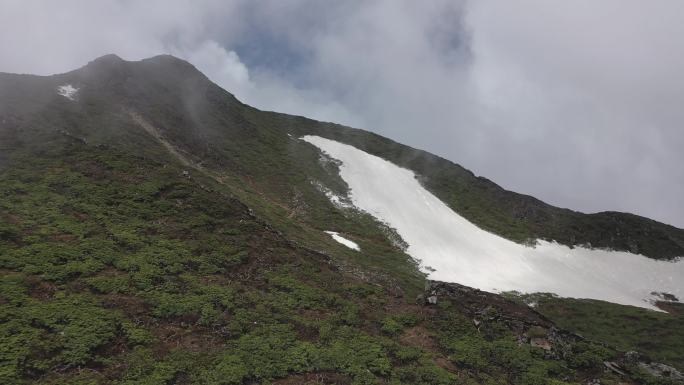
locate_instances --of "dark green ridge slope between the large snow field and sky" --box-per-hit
[288,123,684,259]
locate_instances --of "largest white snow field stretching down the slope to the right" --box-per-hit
[302,136,684,310]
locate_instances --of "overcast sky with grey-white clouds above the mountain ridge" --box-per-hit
[0,0,684,227]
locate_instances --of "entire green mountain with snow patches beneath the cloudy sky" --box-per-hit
[0,55,684,384]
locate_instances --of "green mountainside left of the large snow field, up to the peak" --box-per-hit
[0,54,680,384]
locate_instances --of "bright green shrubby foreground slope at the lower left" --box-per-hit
[0,138,656,384]
